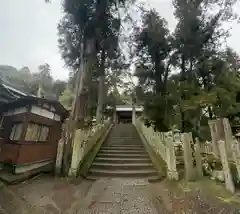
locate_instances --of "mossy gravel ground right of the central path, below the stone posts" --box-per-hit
[151,180,240,214]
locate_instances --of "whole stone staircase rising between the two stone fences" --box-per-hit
[87,124,159,181]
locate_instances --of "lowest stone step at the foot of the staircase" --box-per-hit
[89,168,158,178]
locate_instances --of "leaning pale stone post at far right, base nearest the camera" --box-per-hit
[218,140,235,193]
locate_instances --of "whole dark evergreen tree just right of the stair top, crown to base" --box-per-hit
[131,10,172,131]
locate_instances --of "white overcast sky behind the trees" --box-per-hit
[0,0,240,79]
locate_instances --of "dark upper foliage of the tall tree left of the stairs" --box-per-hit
[58,0,131,69]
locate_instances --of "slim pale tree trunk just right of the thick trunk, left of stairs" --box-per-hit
[96,50,106,124]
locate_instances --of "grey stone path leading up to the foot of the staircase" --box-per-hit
[69,179,158,214]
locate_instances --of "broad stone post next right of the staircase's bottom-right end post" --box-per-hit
[182,133,195,181]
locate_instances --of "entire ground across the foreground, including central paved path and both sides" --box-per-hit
[0,175,240,214]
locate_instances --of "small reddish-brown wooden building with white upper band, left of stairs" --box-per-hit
[0,96,68,174]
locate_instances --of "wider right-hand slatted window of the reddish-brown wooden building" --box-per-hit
[25,123,49,142]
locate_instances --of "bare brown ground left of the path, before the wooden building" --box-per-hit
[0,175,92,214]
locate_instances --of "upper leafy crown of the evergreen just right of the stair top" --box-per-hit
[134,10,171,94]
